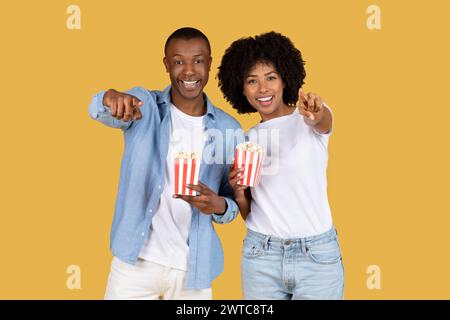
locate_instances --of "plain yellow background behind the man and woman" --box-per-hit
[0,0,450,299]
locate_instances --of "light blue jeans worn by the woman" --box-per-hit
[242,228,344,300]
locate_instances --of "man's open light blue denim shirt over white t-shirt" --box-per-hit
[89,86,244,289]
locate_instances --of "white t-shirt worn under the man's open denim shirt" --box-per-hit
[139,105,206,271]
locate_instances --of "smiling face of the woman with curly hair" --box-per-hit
[243,62,292,121]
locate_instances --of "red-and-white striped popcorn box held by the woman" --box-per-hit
[234,142,264,187]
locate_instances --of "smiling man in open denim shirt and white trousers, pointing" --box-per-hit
[89,28,242,299]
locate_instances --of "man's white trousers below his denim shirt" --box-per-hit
[105,257,212,300]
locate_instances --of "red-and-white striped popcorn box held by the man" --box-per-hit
[175,152,201,196]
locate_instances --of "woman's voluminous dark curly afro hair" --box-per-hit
[217,31,306,113]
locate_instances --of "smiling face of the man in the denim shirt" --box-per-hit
[163,38,212,100]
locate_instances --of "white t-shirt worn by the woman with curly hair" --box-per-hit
[246,108,333,238]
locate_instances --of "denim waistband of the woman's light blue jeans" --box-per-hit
[247,227,337,247]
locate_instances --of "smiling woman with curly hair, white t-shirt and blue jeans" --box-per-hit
[218,32,344,299]
